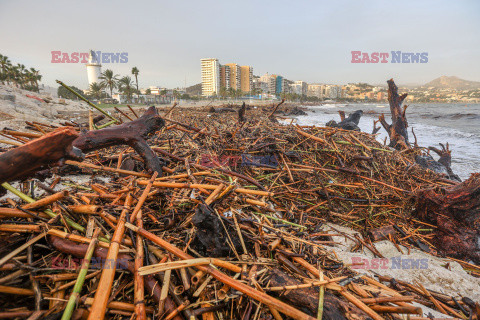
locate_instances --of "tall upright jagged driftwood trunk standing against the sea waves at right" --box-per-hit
[378,79,409,150]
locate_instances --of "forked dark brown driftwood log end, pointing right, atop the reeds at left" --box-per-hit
[73,106,165,176]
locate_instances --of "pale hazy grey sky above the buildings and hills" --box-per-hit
[0,0,480,89]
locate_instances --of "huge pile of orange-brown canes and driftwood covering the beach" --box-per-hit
[0,80,480,320]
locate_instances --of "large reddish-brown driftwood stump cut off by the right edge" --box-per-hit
[416,173,480,263]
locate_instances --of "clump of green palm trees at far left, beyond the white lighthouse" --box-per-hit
[0,54,42,92]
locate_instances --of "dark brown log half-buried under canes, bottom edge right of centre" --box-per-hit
[269,269,369,320]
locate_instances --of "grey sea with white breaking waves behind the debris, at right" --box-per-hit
[290,103,480,180]
